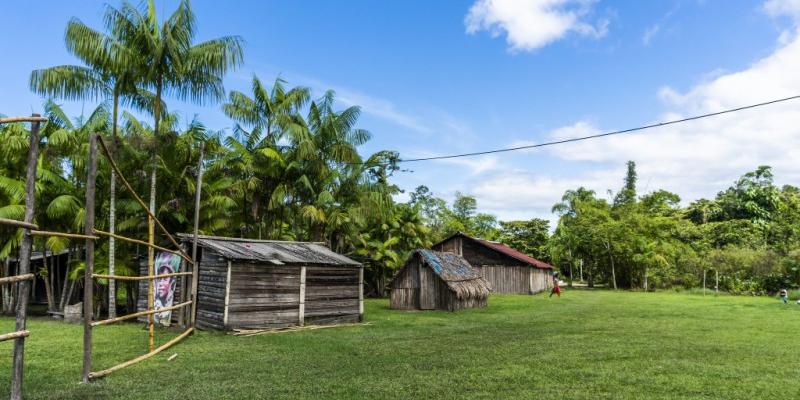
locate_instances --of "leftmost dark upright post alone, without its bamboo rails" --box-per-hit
[11,114,40,400]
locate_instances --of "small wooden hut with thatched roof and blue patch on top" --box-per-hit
[390,250,489,311]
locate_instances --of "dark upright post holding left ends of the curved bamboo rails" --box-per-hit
[83,134,97,383]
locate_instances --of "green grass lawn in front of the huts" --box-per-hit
[0,291,800,400]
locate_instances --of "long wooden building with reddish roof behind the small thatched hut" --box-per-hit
[432,232,553,294]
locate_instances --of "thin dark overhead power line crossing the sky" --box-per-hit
[398,95,800,163]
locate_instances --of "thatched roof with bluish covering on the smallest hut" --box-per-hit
[411,249,490,299]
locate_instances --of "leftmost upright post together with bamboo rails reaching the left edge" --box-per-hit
[0,114,41,400]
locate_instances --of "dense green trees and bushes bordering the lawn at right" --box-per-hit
[550,163,800,294]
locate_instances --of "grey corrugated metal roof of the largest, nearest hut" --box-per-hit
[178,234,361,266]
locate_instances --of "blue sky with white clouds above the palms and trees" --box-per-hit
[0,0,800,227]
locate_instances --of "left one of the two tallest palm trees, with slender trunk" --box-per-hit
[30,14,154,318]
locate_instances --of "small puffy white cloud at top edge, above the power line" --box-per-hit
[464,0,608,51]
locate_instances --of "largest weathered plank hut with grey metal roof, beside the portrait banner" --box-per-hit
[139,235,364,330]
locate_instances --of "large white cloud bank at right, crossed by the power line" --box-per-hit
[550,30,800,200]
